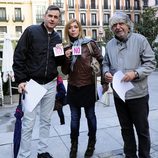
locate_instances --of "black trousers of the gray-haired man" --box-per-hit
[114,95,150,158]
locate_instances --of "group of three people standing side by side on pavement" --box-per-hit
[13,5,156,158]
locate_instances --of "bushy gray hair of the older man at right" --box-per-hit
[109,12,132,30]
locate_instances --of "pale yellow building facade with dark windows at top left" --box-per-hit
[0,0,32,39]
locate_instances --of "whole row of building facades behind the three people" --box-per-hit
[0,0,148,40]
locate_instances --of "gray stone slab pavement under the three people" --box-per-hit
[0,71,158,158]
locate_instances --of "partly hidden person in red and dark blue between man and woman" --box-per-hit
[54,75,67,125]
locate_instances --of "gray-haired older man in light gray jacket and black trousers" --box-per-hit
[102,12,156,158]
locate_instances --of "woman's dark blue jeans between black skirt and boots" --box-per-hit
[70,105,97,139]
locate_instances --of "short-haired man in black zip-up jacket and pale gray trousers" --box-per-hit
[13,5,64,158]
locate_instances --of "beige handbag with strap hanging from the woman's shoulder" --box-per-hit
[87,43,101,76]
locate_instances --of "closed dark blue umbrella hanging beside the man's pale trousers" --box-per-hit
[13,94,24,158]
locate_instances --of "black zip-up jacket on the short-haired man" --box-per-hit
[13,23,64,84]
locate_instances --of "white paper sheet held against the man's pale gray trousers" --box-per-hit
[22,79,47,112]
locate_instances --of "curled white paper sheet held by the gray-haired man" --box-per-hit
[112,71,134,102]
